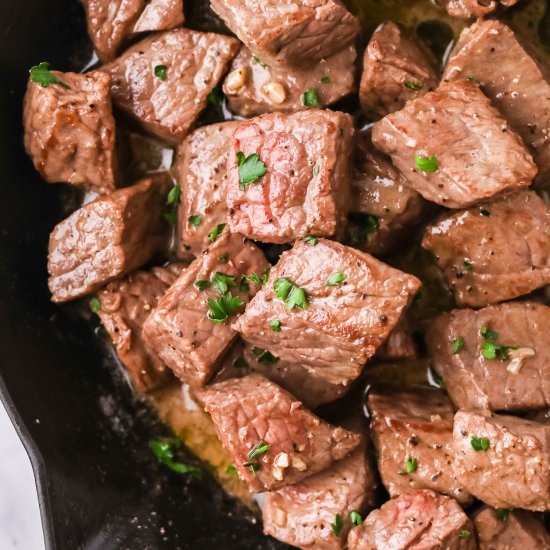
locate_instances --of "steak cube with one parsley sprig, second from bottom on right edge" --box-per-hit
[453,410,550,511]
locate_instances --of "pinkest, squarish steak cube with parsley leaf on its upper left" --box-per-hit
[227,109,353,243]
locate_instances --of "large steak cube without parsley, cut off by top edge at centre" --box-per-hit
[210,0,359,66]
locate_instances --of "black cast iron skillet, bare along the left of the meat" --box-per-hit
[0,0,284,550]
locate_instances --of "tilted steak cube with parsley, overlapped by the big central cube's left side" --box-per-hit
[143,226,268,387]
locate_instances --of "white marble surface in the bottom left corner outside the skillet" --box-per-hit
[0,402,44,550]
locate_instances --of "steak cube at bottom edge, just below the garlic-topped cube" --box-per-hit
[263,446,376,550]
